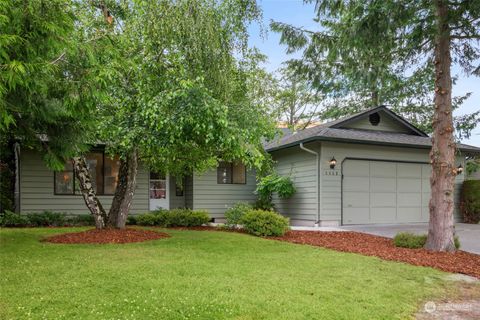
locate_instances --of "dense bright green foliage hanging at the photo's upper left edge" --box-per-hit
[0,0,105,168]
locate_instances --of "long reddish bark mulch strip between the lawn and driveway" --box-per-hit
[270,230,480,279]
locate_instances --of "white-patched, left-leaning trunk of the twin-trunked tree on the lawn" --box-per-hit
[73,157,107,229]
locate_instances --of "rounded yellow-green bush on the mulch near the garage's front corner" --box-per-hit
[241,210,289,236]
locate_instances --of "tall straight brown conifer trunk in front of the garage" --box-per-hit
[425,0,456,251]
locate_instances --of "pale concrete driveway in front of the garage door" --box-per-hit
[340,223,480,254]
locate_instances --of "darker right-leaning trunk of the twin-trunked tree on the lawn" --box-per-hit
[108,150,138,229]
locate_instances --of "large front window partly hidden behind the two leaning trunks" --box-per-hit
[54,151,120,195]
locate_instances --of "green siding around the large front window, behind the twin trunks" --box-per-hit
[20,150,148,214]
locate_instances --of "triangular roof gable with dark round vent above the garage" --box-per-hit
[329,106,428,137]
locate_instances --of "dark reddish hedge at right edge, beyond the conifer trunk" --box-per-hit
[460,180,480,223]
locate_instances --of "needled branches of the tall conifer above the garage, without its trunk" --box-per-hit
[271,0,480,139]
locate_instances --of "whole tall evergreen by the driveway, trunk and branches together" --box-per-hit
[272,0,480,251]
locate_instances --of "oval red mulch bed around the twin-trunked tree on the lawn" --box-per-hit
[44,228,170,244]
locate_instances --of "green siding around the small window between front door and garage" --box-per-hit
[193,169,256,218]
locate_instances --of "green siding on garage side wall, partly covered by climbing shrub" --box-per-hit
[272,143,320,224]
